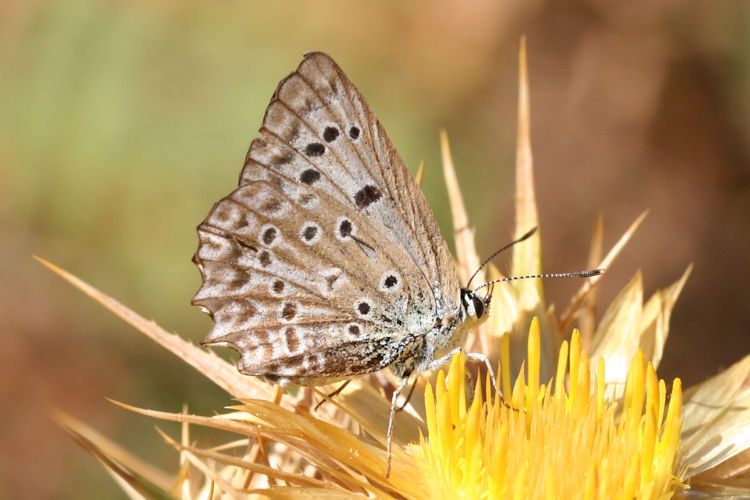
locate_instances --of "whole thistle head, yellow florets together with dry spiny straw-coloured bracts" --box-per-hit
[40,40,750,499]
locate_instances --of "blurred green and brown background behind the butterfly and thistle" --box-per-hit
[0,0,750,498]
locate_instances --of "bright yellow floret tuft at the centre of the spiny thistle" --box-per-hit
[412,320,682,499]
